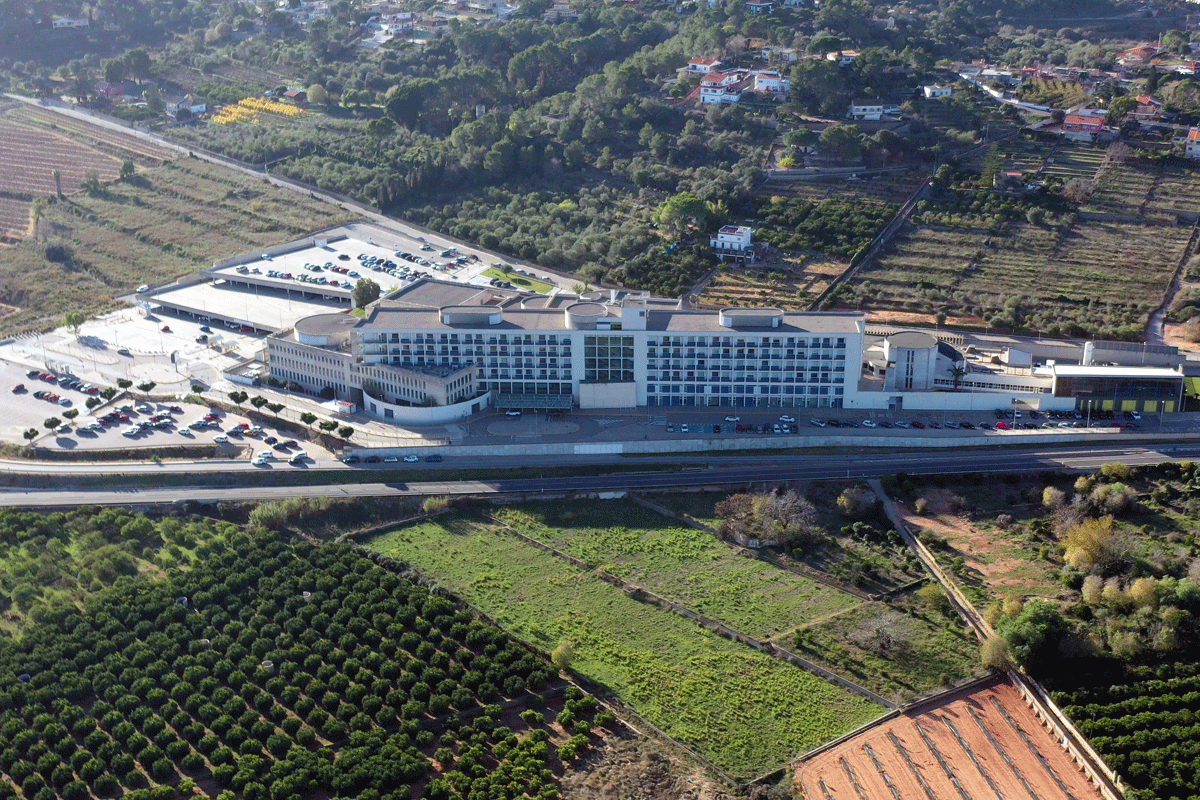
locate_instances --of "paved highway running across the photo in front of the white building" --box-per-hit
[0,443,1200,507]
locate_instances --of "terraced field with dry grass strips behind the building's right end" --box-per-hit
[841,211,1192,339]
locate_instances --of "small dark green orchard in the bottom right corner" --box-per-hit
[1054,662,1200,798]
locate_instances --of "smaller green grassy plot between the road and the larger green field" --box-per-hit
[496,500,858,638]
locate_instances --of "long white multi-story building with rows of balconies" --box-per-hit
[266,281,864,423]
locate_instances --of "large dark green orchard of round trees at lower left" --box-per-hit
[0,511,614,800]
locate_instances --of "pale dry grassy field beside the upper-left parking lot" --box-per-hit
[0,148,352,335]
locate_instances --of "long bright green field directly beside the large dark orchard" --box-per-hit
[367,515,881,776]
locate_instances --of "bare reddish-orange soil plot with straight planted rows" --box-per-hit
[796,678,1100,800]
